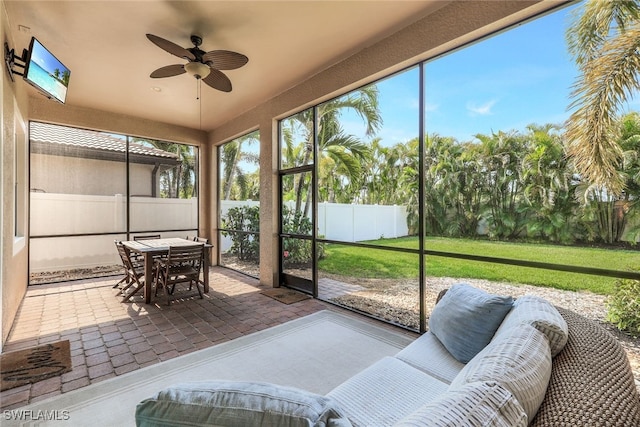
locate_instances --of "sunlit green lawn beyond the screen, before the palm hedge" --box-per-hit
[319,237,640,295]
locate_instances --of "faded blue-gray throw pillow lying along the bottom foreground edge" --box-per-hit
[136,381,351,427]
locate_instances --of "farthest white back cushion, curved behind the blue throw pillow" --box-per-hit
[496,295,569,357]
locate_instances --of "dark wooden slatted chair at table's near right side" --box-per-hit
[155,245,204,305]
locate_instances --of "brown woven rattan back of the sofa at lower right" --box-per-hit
[530,307,640,427]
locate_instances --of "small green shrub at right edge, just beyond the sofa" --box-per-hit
[607,279,640,337]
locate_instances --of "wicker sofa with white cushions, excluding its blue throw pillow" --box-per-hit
[136,285,640,427]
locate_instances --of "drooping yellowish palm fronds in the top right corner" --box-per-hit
[567,0,640,194]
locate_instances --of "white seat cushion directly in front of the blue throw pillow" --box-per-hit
[395,332,464,384]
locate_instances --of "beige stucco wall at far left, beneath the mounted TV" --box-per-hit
[0,2,28,351]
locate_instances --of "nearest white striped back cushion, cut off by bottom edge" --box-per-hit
[395,381,527,427]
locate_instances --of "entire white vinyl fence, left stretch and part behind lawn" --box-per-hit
[30,192,408,272]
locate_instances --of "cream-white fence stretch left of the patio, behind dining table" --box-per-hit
[29,192,198,272]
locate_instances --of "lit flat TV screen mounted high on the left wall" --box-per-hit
[24,37,71,104]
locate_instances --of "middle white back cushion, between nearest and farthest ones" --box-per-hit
[449,324,551,420]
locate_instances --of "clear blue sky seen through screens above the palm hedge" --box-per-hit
[343,1,577,145]
